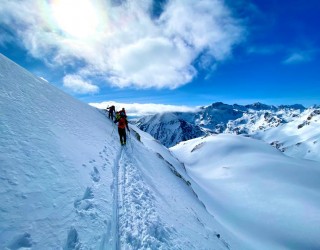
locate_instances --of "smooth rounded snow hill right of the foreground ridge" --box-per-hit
[171,134,320,249]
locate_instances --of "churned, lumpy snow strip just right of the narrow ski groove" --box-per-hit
[118,145,175,249]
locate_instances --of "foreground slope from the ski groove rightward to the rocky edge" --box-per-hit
[109,128,244,250]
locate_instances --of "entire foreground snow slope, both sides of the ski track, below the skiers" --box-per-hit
[0,55,248,249]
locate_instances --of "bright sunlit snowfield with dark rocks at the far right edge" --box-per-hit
[254,107,320,162]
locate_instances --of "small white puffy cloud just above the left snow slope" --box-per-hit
[63,75,99,94]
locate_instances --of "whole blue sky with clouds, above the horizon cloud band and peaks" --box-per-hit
[0,0,320,106]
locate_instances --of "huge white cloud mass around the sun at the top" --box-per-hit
[0,0,243,88]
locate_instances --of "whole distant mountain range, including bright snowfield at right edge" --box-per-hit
[136,102,320,160]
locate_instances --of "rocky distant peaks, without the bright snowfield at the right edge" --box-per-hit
[136,102,305,147]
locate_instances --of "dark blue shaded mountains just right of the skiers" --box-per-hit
[136,102,243,147]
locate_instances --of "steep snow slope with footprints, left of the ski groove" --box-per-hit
[0,52,119,249]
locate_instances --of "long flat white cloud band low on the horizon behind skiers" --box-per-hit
[90,101,198,117]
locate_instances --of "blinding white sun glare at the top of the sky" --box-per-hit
[51,0,99,38]
